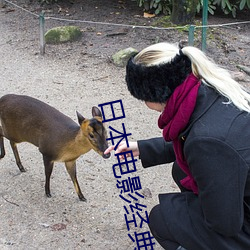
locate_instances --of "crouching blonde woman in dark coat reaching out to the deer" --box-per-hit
[105,43,250,250]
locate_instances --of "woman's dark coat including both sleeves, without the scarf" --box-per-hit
[138,85,250,250]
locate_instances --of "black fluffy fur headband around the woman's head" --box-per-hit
[126,51,192,103]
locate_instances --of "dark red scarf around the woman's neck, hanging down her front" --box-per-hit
[158,73,200,194]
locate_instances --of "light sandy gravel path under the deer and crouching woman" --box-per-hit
[0,3,176,250]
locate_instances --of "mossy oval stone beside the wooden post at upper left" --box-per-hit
[45,26,82,44]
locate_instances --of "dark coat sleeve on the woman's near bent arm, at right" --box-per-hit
[184,137,248,237]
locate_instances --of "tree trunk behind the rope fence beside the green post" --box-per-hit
[171,0,198,25]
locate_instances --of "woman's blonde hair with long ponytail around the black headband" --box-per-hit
[134,43,250,113]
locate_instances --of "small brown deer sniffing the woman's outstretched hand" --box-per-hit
[0,94,110,201]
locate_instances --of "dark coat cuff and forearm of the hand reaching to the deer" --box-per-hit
[138,137,175,168]
